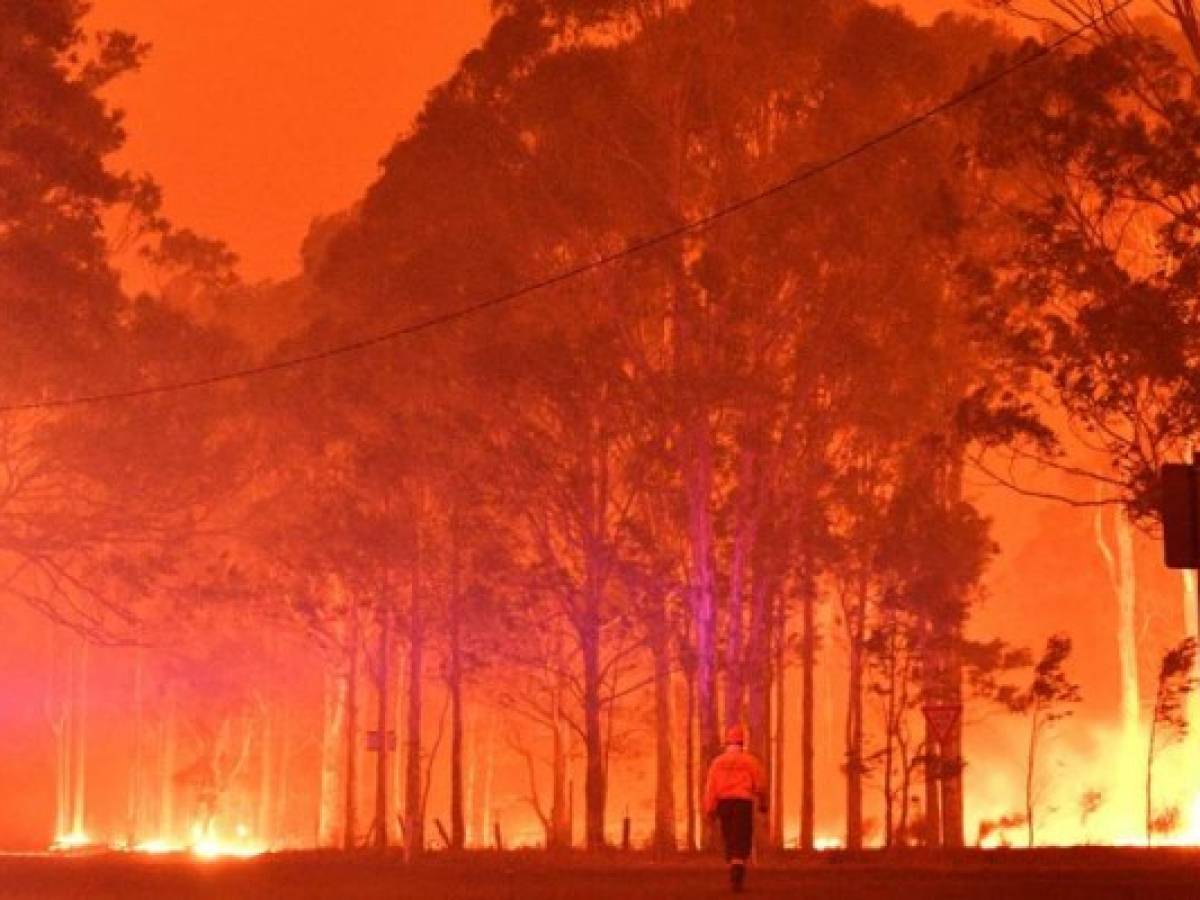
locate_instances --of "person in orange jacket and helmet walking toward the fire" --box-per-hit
[704,725,767,893]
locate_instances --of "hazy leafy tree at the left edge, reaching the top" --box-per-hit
[0,0,255,643]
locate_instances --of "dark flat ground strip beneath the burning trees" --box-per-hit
[0,848,1200,900]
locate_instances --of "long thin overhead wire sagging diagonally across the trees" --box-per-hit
[0,0,1133,413]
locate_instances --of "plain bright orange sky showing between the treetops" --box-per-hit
[91,0,984,280]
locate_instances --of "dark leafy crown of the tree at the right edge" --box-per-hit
[973,32,1200,522]
